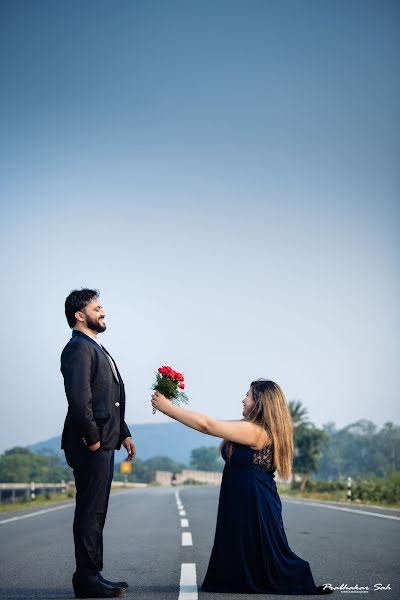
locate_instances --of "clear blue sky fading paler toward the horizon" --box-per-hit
[0,0,400,451]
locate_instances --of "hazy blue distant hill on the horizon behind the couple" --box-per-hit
[28,422,221,465]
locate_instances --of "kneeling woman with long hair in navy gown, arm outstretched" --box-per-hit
[152,379,332,595]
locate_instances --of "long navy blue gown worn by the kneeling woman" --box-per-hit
[201,444,332,595]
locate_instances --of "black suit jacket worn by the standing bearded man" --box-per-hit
[61,330,131,450]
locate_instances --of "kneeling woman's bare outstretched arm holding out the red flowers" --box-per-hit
[151,392,268,450]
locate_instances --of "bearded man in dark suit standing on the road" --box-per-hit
[61,289,136,598]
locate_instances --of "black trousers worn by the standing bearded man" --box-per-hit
[64,445,114,576]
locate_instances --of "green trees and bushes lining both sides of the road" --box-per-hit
[0,400,400,510]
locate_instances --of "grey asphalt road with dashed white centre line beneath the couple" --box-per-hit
[0,486,400,600]
